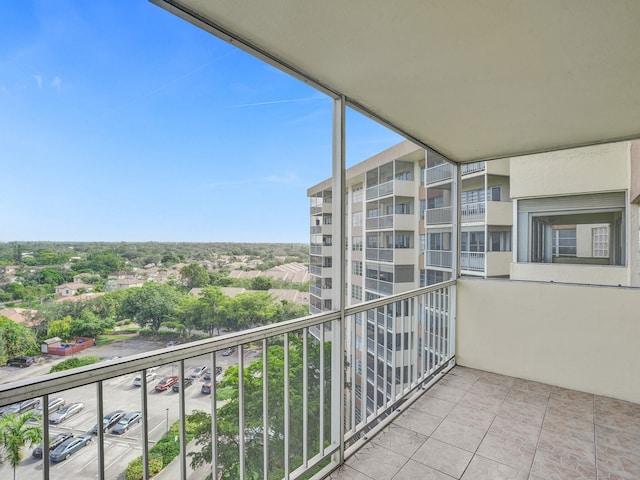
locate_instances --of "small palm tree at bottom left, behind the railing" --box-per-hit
[0,413,42,480]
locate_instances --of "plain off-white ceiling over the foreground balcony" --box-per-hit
[152,0,640,162]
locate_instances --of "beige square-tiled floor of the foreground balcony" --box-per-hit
[329,367,640,480]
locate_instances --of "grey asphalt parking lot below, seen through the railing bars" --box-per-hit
[0,341,258,480]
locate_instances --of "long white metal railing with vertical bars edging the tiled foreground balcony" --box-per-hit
[0,281,456,480]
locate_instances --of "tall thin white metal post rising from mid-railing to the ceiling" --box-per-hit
[331,96,346,463]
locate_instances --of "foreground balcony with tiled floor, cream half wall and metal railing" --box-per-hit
[5,279,640,480]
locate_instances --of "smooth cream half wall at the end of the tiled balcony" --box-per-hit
[456,279,640,403]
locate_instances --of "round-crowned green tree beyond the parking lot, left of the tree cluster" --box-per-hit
[119,282,180,334]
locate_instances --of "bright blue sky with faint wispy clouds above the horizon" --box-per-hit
[0,0,401,243]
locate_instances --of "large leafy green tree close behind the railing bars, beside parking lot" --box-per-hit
[190,335,331,480]
